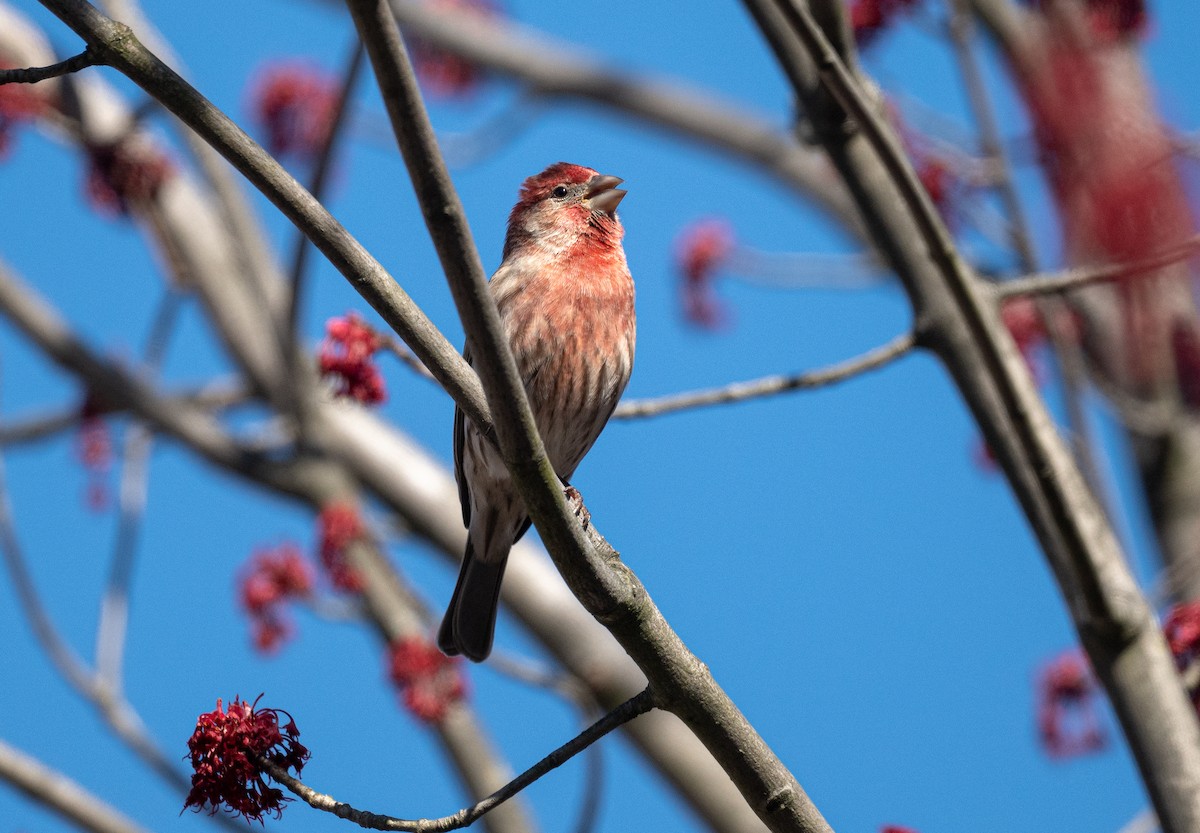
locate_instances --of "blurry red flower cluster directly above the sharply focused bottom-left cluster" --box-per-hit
[241,544,313,653]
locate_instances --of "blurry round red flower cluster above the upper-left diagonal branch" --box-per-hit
[251,62,340,158]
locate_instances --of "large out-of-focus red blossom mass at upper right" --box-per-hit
[1021,19,1195,389]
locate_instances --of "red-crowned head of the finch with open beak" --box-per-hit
[504,162,625,258]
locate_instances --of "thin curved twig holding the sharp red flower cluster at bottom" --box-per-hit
[262,688,655,833]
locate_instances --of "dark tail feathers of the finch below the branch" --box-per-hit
[438,535,508,663]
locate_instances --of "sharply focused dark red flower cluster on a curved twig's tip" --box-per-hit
[184,697,308,822]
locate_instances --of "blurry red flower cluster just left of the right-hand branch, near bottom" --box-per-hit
[1038,651,1108,757]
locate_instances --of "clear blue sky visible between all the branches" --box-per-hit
[0,0,1200,833]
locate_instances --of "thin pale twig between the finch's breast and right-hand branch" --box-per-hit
[613,332,917,419]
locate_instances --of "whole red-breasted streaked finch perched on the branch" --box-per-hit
[438,162,636,663]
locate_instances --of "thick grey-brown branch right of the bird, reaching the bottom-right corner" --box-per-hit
[763,0,1200,833]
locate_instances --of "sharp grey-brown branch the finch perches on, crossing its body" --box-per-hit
[348,0,828,831]
